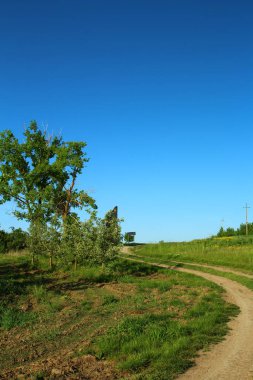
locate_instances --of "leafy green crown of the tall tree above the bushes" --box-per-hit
[0,121,96,223]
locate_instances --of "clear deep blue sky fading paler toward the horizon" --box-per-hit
[0,0,253,241]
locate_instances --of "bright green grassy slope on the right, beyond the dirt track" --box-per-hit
[131,237,253,272]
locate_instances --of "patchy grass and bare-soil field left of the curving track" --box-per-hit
[0,256,238,380]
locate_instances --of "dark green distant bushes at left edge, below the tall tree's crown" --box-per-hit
[0,227,28,253]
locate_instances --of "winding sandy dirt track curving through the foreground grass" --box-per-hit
[125,258,253,380]
